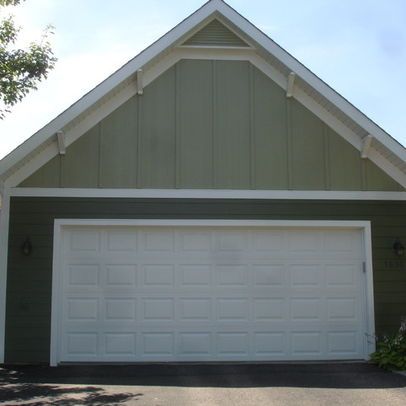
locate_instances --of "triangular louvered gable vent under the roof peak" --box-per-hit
[182,20,250,48]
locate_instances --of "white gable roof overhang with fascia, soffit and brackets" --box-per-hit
[0,0,406,187]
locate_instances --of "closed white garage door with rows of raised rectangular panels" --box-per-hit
[53,226,366,362]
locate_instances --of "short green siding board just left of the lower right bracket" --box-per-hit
[327,127,362,190]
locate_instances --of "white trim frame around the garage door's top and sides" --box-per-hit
[50,219,375,366]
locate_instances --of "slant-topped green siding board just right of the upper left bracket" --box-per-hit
[139,67,176,188]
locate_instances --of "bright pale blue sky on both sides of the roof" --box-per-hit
[0,0,406,158]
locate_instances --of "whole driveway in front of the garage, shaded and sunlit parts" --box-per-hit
[0,363,406,406]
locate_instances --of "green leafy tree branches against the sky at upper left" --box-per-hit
[0,0,56,120]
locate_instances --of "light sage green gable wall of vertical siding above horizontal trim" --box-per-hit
[21,60,403,191]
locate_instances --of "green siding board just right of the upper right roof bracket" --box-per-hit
[291,100,325,190]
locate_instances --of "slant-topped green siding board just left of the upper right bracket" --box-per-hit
[253,69,289,189]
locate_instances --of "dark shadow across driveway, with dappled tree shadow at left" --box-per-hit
[0,363,406,406]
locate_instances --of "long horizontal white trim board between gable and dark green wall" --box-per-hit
[8,188,406,201]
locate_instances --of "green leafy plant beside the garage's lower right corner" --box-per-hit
[371,319,406,370]
